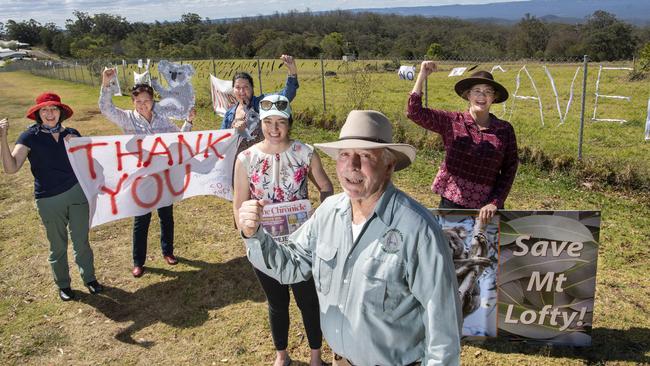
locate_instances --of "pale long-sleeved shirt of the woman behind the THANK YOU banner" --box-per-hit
[99,87,192,135]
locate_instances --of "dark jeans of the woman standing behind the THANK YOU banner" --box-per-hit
[133,205,174,266]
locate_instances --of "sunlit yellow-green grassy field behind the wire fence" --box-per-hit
[24,60,650,188]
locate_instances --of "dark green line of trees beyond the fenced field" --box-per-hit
[0,11,650,61]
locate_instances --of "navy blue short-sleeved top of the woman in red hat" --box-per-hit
[16,124,81,198]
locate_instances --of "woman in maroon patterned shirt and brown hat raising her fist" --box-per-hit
[407,61,519,223]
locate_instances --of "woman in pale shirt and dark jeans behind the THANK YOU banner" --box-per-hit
[99,69,196,277]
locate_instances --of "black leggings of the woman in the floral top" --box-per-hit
[254,268,323,351]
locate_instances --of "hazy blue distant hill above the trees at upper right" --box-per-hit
[351,0,650,25]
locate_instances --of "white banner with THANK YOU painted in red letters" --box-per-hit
[65,129,238,227]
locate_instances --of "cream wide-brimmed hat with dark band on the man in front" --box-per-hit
[314,110,415,171]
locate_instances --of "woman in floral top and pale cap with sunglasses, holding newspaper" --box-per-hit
[233,94,333,366]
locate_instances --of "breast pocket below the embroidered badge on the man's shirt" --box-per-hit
[362,256,406,313]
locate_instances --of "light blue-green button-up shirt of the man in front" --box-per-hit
[245,184,462,366]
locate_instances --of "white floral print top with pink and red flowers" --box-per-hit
[237,140,314,203]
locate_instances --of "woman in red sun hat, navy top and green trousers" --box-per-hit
[0,93,103,301]
